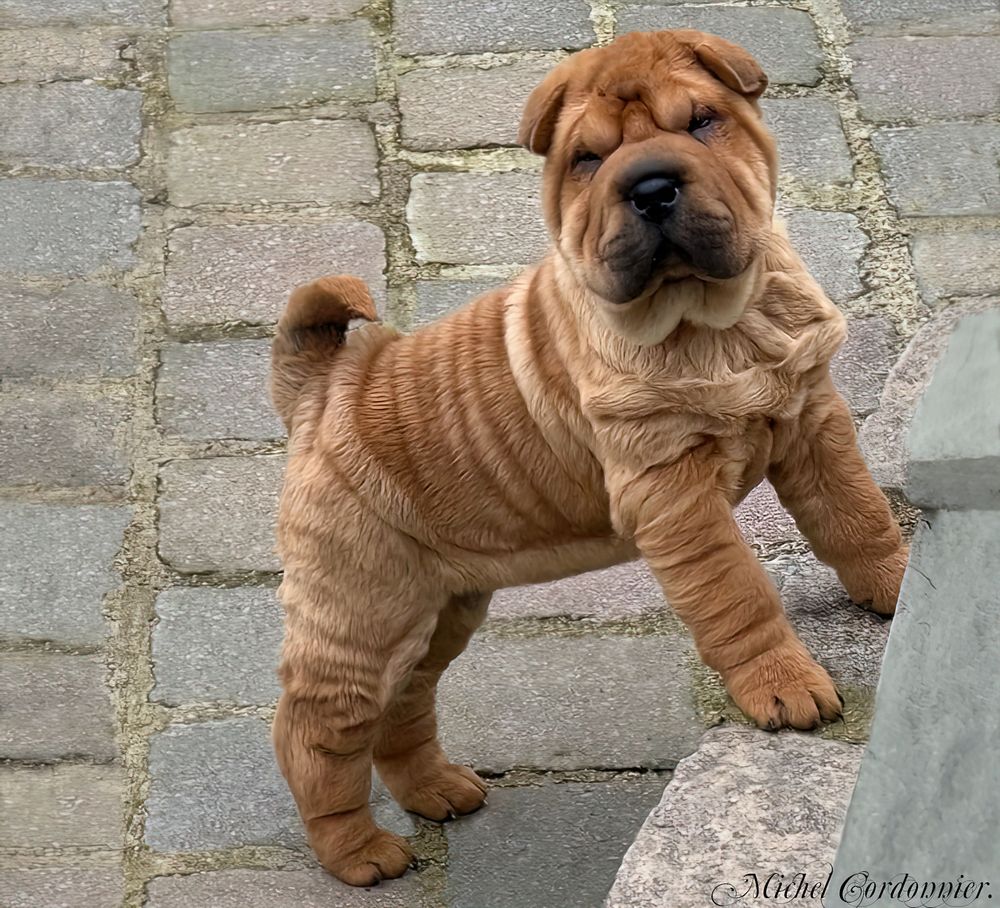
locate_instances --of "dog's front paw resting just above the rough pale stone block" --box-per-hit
[724,640,844,731]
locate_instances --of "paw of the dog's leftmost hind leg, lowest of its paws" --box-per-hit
[306,808,413,886]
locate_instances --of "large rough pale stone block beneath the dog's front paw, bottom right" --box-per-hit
[605,726,862,908]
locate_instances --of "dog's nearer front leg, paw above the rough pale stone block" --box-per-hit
[606,452,842,729]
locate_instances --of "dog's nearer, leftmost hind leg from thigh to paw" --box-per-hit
[273,569,436,886]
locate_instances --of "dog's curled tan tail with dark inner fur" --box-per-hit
[271,275,378,430]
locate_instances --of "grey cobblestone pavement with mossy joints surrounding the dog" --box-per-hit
[0,0,1000,908]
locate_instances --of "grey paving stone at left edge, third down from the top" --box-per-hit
[0,82,142,169]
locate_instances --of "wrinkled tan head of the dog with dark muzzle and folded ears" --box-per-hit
[519,30,777,336]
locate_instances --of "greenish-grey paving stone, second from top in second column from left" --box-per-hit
[167,19,375,113]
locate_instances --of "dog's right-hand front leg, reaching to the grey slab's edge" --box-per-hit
[768,378,909,615]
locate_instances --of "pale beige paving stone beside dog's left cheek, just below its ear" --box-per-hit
[406,173,549,265]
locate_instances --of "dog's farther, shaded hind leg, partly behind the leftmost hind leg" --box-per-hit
[375,593,490,820]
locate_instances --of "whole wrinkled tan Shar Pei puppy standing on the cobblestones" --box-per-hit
[272,31,907,885]
